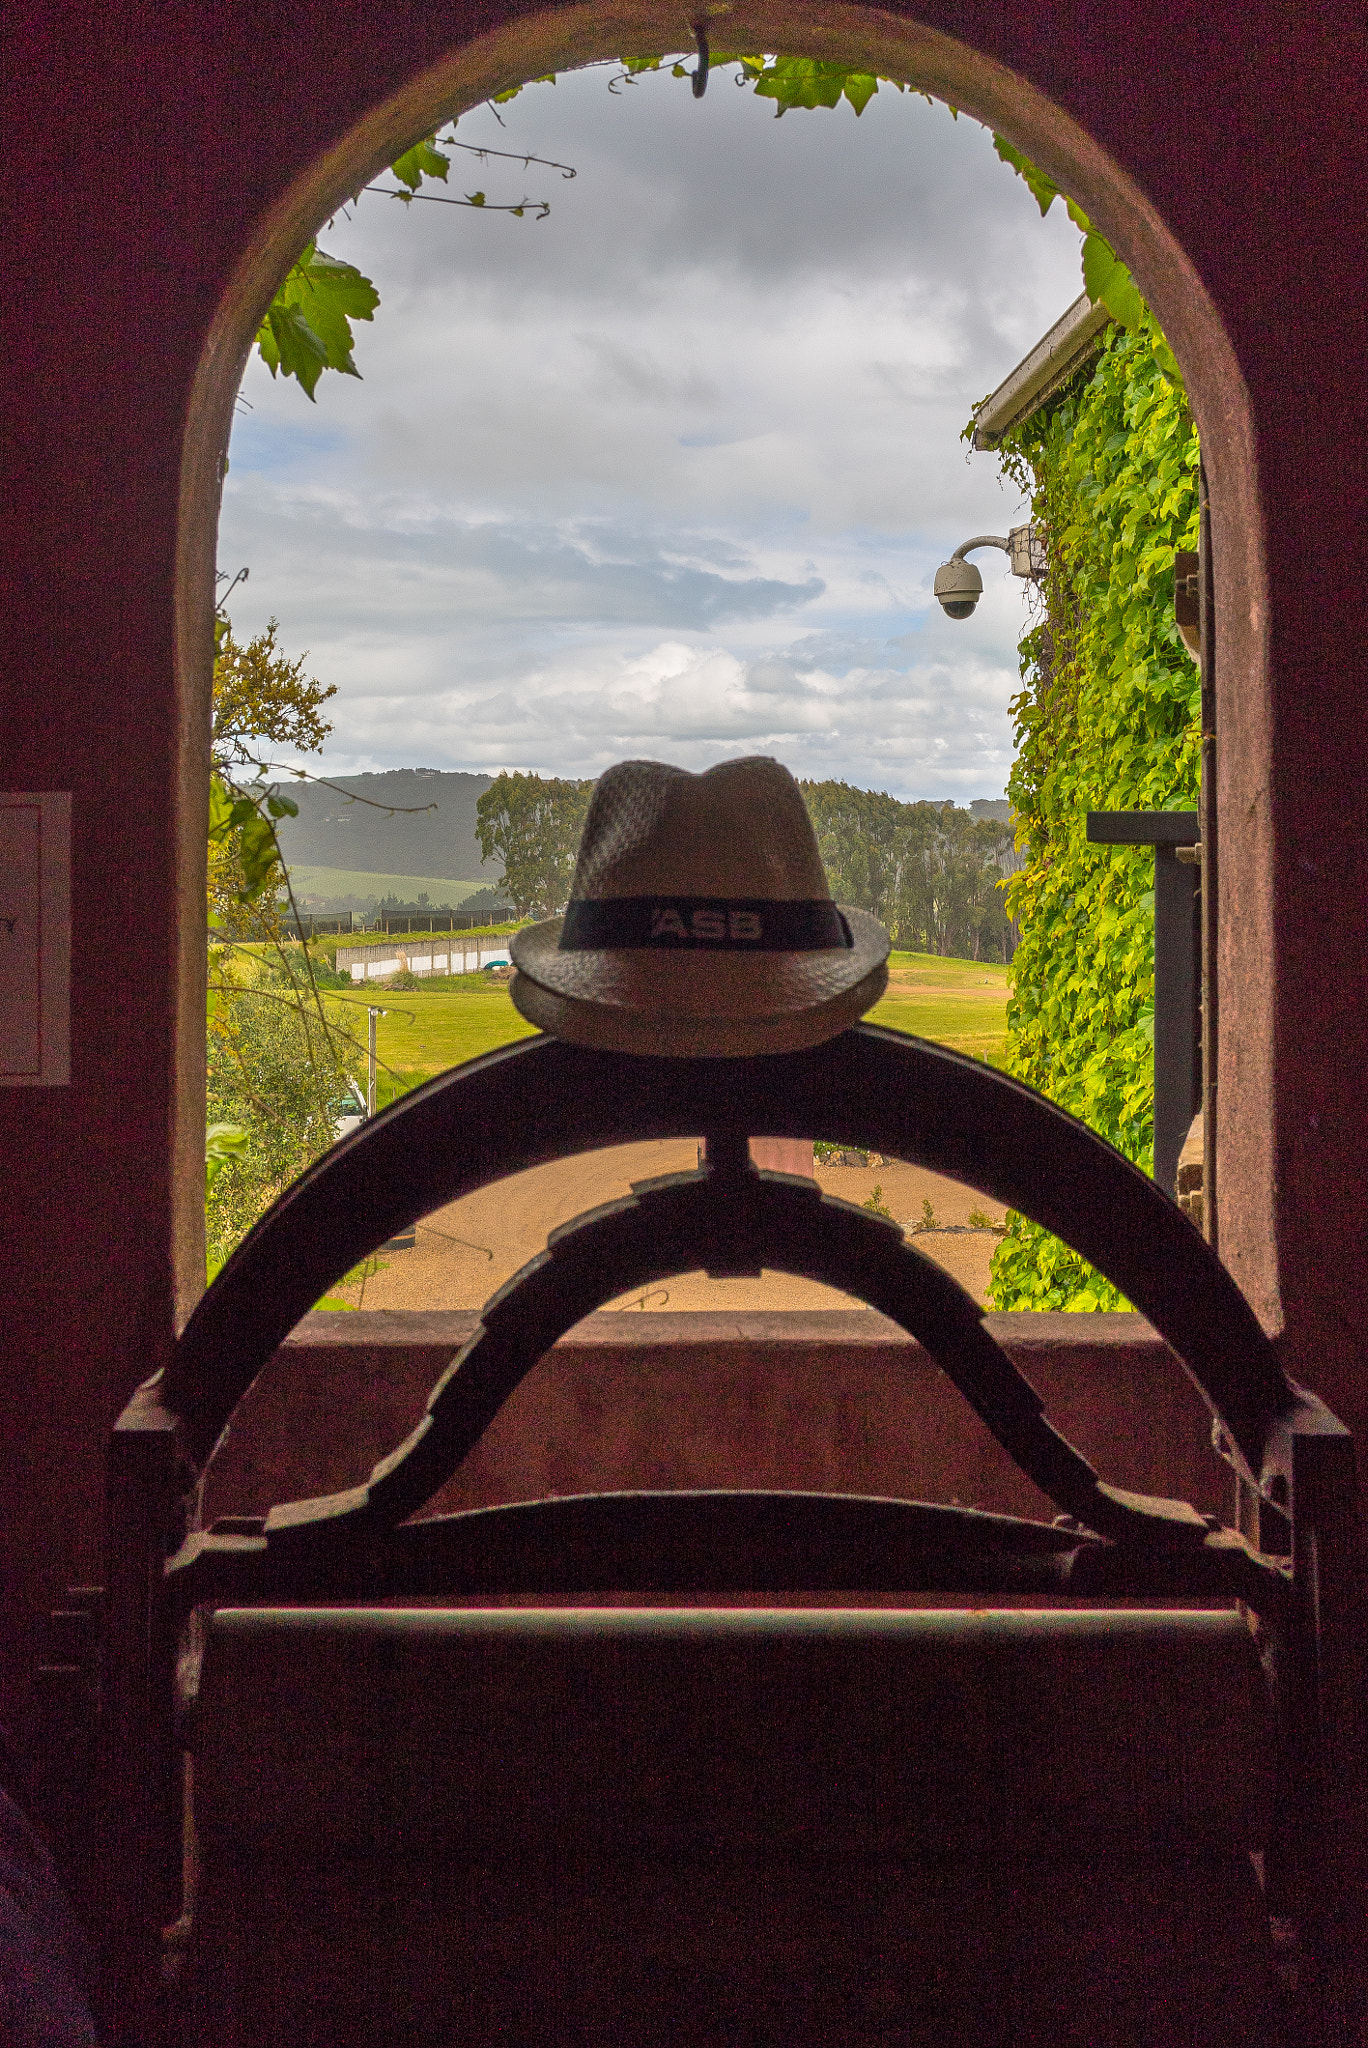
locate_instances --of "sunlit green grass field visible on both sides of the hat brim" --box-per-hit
[348,952,1008,1102]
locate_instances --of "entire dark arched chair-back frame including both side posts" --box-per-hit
[104,1040,1362,2048]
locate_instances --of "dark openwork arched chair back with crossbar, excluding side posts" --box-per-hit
[125,1024,1359,1622]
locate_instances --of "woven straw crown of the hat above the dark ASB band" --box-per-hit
[571,754,831,903]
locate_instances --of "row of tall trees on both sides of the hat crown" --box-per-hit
[475,774,1018,961]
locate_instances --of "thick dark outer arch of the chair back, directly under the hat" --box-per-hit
[167,1024,1311,1487]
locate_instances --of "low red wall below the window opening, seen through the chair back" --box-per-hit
[203,1309,1235,1524]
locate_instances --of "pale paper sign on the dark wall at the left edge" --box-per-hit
[0,791,72,1087]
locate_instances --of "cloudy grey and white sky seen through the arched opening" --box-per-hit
[219,68,1081,803]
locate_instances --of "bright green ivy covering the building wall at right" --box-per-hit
[993,313,1200,1309]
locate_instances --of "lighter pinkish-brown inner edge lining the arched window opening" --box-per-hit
[176,0,1280,1325]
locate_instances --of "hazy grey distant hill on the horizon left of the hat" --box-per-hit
[276,768,504,883]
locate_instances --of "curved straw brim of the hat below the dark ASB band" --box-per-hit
[510,905,889,1059]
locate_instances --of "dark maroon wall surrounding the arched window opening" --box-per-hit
[0,0,1368,1728]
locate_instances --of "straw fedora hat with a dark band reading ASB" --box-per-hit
[510,756,889,1057]
